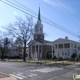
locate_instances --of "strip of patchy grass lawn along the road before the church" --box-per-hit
[2,59,71,67]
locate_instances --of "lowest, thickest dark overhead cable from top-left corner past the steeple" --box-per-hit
[1,1,78,37]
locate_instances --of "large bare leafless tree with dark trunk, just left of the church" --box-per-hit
[6,17,33,61]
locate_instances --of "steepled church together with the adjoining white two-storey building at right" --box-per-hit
[28,8,80,59]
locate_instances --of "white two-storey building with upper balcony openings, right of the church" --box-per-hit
[53,37,80,59]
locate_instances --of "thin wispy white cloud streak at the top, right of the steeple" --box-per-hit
[42,0,74,14]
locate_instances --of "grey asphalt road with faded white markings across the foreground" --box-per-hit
[0,62,80,80]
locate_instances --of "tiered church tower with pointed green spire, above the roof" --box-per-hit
[34,7,44,40]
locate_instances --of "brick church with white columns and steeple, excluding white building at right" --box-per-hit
[28,8,54,59]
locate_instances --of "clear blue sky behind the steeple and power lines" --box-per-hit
[0,0,80,41]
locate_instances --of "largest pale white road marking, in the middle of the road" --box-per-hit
[30,67,63,73]
